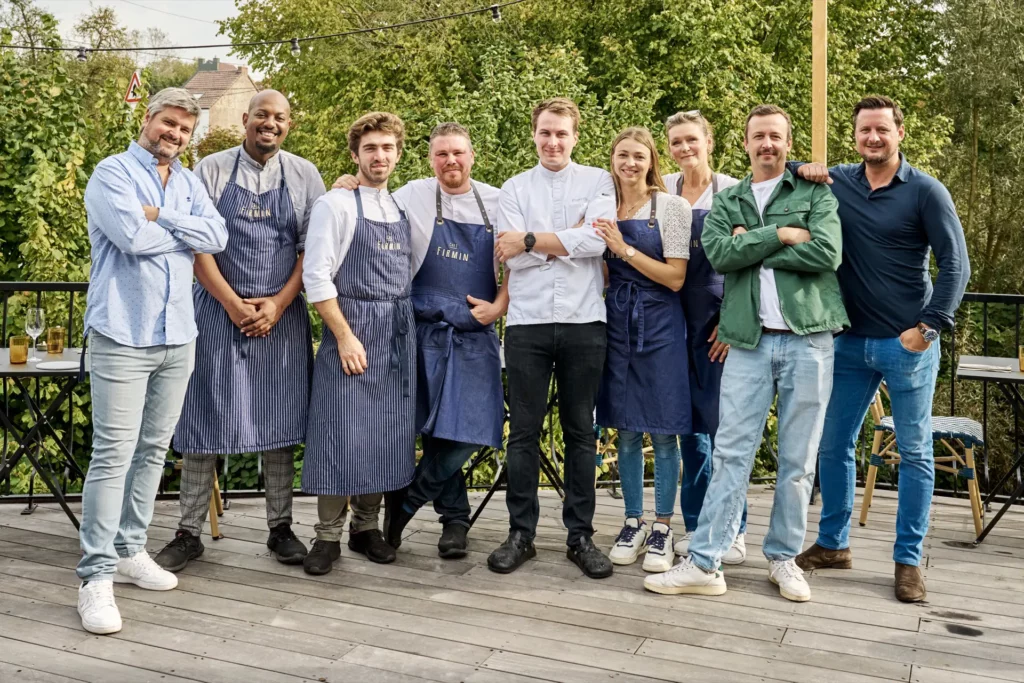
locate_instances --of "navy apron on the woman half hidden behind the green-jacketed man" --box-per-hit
[676,173,725,436]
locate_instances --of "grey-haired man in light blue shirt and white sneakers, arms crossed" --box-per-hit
[77,88,227,634]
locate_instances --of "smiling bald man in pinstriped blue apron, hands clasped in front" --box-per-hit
[157,90,325,571]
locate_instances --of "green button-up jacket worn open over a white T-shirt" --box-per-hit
[700,171,850,349]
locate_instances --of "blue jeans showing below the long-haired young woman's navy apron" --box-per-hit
[618,429,679,517]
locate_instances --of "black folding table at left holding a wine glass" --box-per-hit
[0,348,85,528]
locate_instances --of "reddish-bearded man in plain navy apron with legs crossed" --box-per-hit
[335,123,508,558]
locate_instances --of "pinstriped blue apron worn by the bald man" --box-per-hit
[174,150,312,454]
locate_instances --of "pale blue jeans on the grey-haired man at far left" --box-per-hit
[77,333,196,581]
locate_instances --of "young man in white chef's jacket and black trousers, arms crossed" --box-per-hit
[487,97,615,579]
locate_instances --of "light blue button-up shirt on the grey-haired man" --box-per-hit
[85,142,227,347]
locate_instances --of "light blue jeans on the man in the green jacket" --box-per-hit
[690,332,833,571]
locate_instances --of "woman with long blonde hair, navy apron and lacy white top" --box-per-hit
[594,128,690,571]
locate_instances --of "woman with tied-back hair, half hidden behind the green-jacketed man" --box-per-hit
[665,110,746,564]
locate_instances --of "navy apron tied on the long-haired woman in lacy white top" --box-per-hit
[597,195,691,434]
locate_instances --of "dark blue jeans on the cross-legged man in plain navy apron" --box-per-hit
[402,435,480,528]
